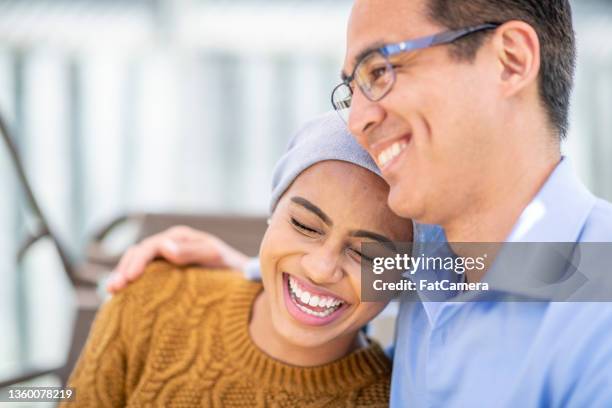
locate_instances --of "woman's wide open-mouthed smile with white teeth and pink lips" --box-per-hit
[283,272,350,326]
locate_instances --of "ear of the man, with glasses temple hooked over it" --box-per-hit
[493,21,541,96]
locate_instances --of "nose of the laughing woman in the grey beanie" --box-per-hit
[302,244,343,284]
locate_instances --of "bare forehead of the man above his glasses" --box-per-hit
[344,0,432,68]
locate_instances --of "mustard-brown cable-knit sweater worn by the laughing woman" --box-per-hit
[65,261,391,407]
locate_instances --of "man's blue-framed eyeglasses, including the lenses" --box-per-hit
[331,23,501,123]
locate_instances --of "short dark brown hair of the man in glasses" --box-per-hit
[427,0,576,139]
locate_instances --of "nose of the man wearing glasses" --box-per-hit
[348,87,385,150]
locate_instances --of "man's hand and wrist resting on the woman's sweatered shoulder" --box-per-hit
[107,226,260,293]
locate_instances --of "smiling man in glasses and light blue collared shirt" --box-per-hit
[332,0,612,407]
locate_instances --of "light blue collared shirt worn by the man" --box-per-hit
[391,159,612,407]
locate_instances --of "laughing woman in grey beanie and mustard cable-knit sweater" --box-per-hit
[61,113,412,407]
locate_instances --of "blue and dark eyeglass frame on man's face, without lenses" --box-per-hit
[331,22,503,113]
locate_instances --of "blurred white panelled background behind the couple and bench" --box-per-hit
[0,0,612,396]
